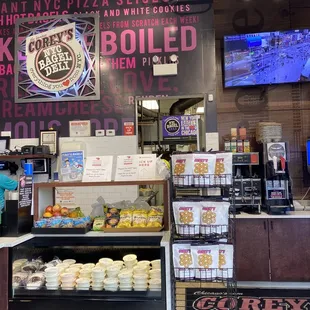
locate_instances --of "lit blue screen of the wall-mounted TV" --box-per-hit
[224,29,310,87]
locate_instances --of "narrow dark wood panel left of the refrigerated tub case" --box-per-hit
[0,248,9,310]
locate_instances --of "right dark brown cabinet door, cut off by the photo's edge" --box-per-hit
[269,219,310,282]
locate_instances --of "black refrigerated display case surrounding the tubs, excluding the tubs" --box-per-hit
[9,232,170,310]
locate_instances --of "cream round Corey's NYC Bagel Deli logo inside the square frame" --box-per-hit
[26,23,85,92]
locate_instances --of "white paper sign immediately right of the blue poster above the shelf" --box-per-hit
[83,156,113,182]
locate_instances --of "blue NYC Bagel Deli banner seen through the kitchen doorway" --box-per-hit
[162,115,198,139]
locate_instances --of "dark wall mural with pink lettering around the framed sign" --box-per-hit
[0,0,215,138]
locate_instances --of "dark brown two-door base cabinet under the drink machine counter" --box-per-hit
[236,211,310,282]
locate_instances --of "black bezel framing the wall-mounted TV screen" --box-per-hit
[221,27,310,89]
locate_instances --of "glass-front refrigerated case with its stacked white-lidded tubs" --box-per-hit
[9,233,166,310]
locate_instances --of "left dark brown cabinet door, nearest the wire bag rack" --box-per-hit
[236,219,269,281]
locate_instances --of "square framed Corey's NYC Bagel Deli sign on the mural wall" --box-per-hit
[15,14,100,103]
